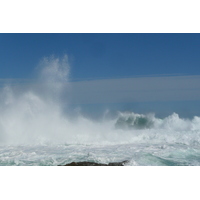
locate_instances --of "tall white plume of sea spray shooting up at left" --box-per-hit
[0,55,69,144]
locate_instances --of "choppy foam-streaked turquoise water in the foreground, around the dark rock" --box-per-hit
[0,141,200,166]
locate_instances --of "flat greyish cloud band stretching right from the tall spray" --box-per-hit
[69,76,200,104]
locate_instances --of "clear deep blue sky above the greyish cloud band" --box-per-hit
[0,34,200,79]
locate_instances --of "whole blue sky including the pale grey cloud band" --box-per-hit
[0,34,200,116]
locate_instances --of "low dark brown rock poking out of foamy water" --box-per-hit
[59,160,128,166]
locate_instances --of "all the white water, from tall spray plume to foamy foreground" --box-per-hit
[0,56,200,165]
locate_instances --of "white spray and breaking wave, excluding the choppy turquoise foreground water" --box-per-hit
[0,55,200,145]
